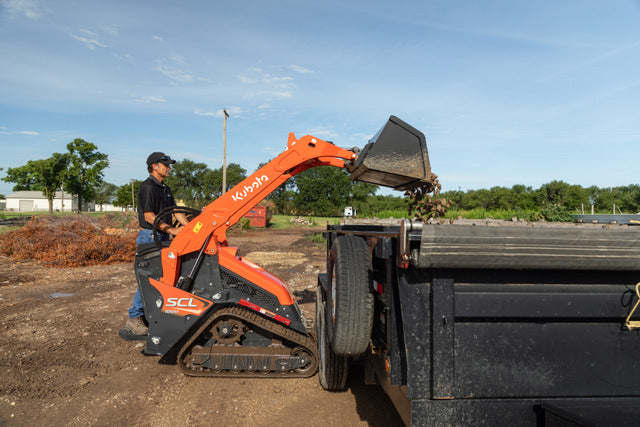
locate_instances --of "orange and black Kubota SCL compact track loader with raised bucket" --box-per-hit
[122,116,430,378]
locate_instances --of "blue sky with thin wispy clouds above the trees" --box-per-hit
[0,0,640,195]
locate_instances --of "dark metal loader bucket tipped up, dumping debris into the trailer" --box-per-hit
[349,116,431,190]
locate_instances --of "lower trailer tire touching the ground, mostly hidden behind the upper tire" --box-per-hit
[315,286,349,391]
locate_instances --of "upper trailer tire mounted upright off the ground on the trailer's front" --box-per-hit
[326,234,373,356]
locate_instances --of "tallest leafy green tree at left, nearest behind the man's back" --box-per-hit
[65,138,109,212]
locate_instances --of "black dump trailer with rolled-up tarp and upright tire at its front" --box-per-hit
[316,220,640,426]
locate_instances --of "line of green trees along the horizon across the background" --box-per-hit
[2,138,640,217]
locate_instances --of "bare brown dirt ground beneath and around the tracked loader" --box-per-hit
[0,228,402,426]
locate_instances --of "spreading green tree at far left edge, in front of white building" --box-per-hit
[3,153,69,214]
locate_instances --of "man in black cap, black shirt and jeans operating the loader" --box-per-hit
[125,152,188,336]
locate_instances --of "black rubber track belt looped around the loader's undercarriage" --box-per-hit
[178,307,318,378]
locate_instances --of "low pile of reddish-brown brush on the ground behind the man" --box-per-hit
[0,215,137,267]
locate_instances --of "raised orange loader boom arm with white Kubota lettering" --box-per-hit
[161,133,356,286]
